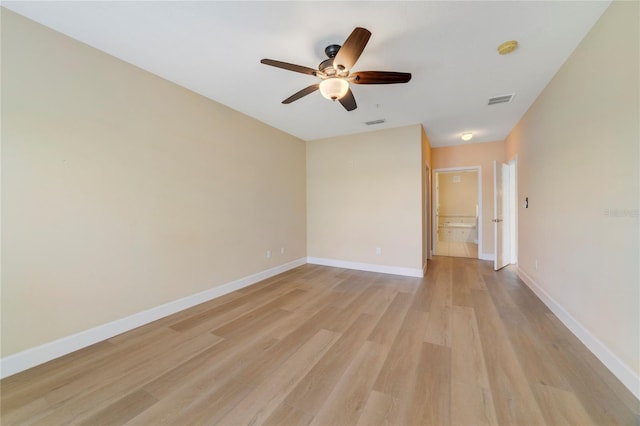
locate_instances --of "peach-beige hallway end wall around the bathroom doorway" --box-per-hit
[431,141,505,258]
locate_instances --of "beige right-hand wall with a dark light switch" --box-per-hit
[506,2,640,386]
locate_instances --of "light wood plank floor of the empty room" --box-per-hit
[0,257,639,425]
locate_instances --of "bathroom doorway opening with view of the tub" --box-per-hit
[433,167,482,259]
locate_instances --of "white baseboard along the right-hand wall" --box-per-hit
[518,267,640,399]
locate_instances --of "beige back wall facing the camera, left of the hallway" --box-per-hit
[307,125,422,269]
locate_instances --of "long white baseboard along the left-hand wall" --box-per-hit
[0,258,306,378]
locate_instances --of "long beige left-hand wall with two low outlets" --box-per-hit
[2,9,306,356]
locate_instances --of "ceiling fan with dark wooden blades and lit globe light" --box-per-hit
[260,27,411,111]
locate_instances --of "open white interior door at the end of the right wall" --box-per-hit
[493,161,510,271]
